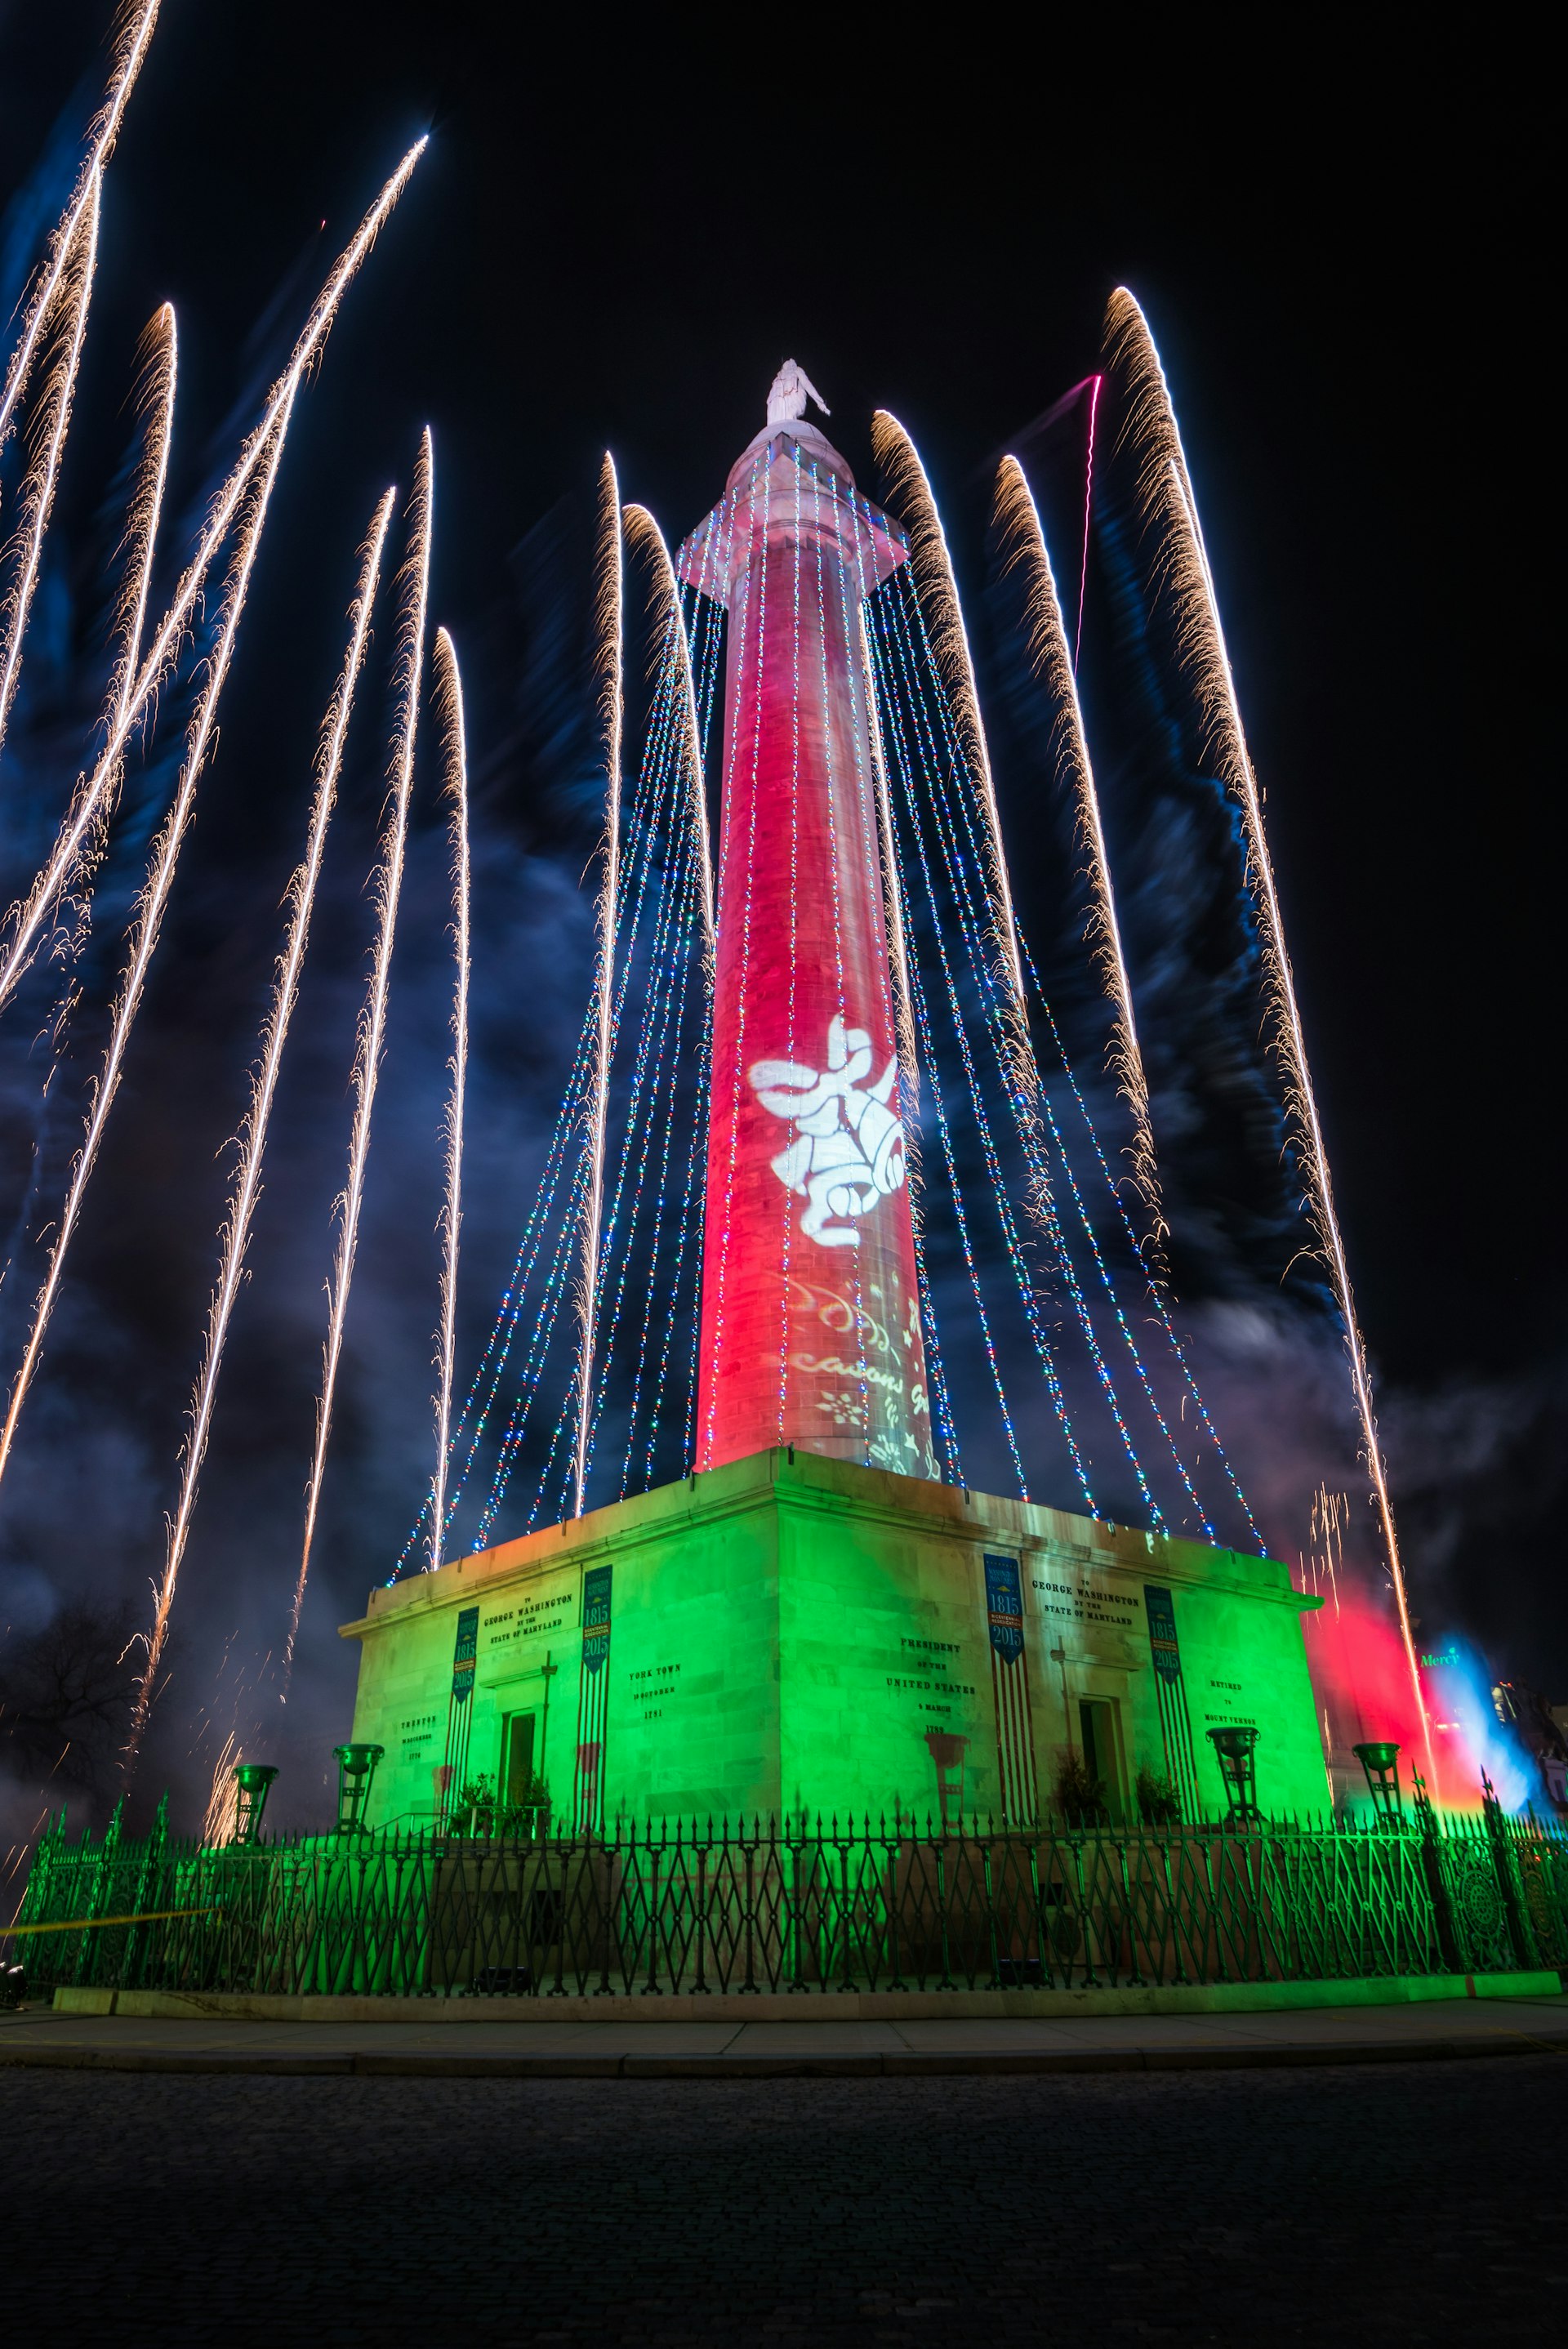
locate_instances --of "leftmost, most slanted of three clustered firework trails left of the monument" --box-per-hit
[145,491,394,1719]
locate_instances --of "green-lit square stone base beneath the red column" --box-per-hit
[343,1449,1329,1830]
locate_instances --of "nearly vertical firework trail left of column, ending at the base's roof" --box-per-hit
[572,456,625,1518]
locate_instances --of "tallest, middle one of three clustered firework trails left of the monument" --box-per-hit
[282,427,434,1672]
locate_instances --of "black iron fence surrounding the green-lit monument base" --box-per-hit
[7,1804,1568,1997]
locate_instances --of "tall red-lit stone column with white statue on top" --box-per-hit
[679,362,937,1475]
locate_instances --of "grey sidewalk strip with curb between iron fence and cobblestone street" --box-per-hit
[0,2032,1568,2079]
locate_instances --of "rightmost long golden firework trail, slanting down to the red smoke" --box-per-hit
[1106,287,1434,1772]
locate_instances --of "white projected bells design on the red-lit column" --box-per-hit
[746,1019,906,1247]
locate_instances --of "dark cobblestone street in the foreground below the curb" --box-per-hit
[0,2056,1568,2349]
